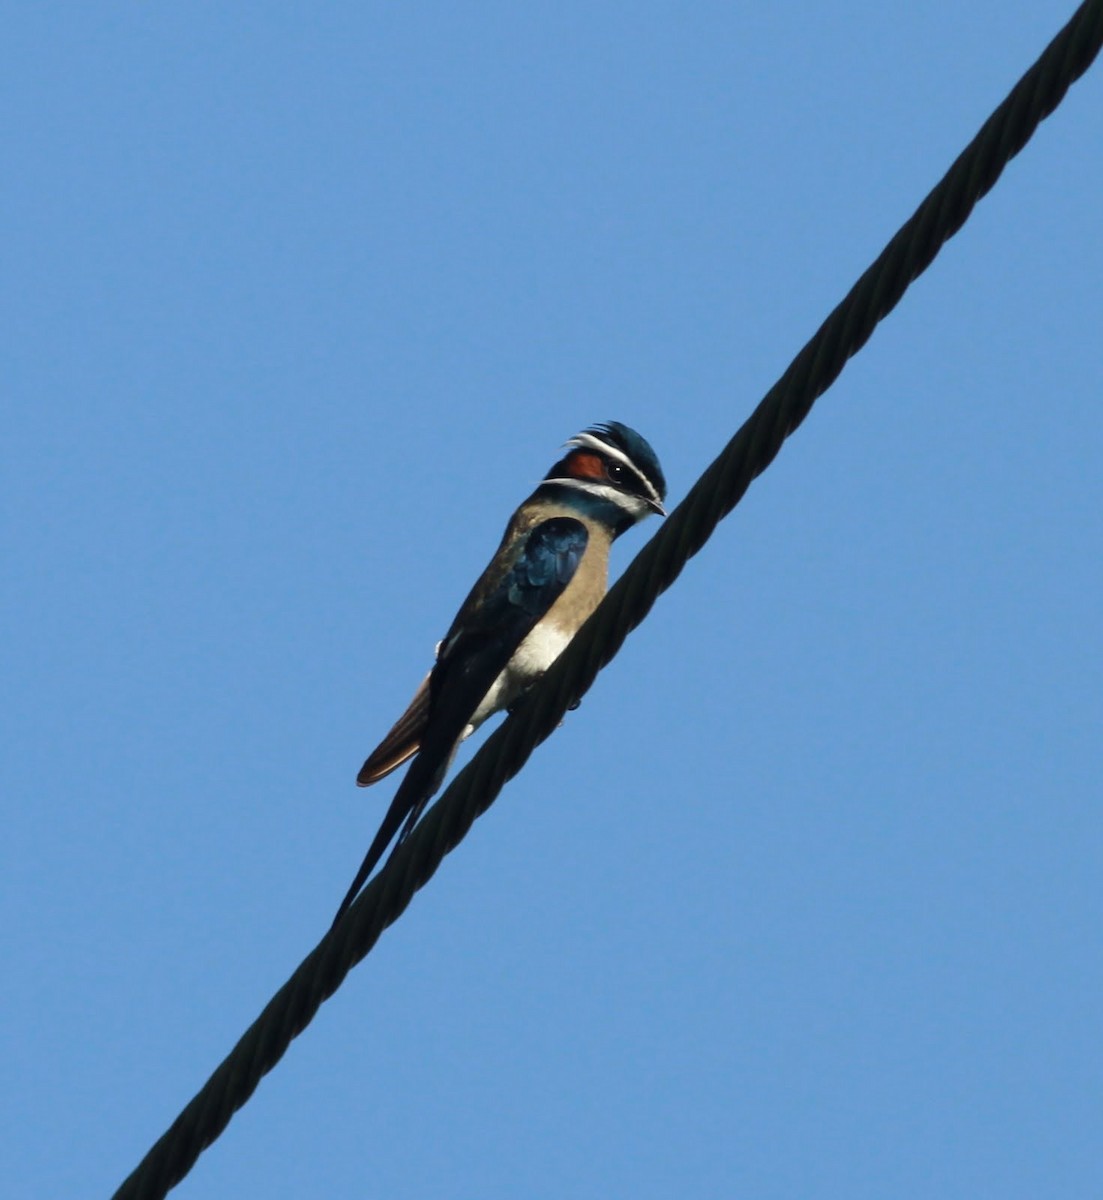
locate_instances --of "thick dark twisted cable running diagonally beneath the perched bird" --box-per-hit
[114,0,1103,1200]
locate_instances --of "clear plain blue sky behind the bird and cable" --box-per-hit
[0,0,1103,1200]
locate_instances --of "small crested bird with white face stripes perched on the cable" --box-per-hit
[334,421,666,926]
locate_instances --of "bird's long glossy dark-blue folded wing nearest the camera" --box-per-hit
[334,517,588,925]
